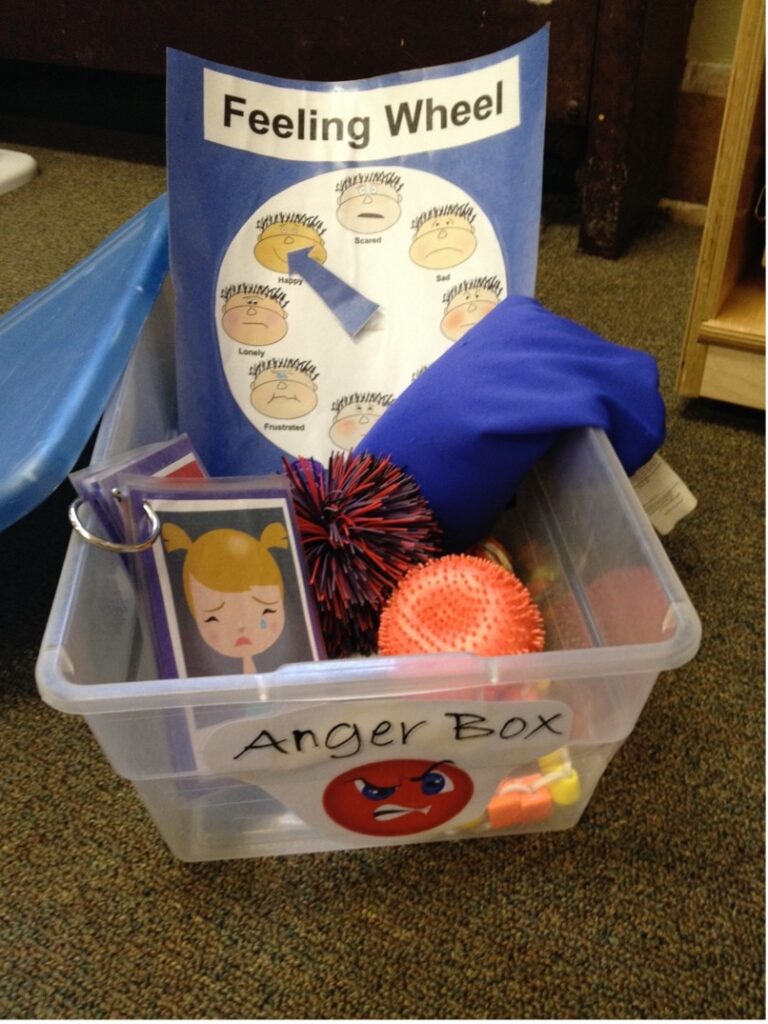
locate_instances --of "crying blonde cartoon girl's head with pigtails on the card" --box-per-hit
[163,522,288,672]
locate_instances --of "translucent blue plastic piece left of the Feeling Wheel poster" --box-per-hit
[0,196,168,529]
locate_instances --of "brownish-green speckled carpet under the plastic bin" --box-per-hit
[0,124,765,1019]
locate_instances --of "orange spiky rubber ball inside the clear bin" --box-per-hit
[379,555,544,657]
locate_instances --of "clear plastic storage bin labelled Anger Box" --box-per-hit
[37,284,700,860]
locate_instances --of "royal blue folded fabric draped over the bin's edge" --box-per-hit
[355,296,665,551]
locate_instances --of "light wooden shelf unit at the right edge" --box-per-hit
[677,0,765,409]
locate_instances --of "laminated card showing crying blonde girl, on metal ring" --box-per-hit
[120,475,325,678]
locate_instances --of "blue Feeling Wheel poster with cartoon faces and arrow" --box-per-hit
[168,29,548,476]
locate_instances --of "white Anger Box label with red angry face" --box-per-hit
[191,699,572,845]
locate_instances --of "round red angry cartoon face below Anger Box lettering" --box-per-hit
[323,759,474,836]
